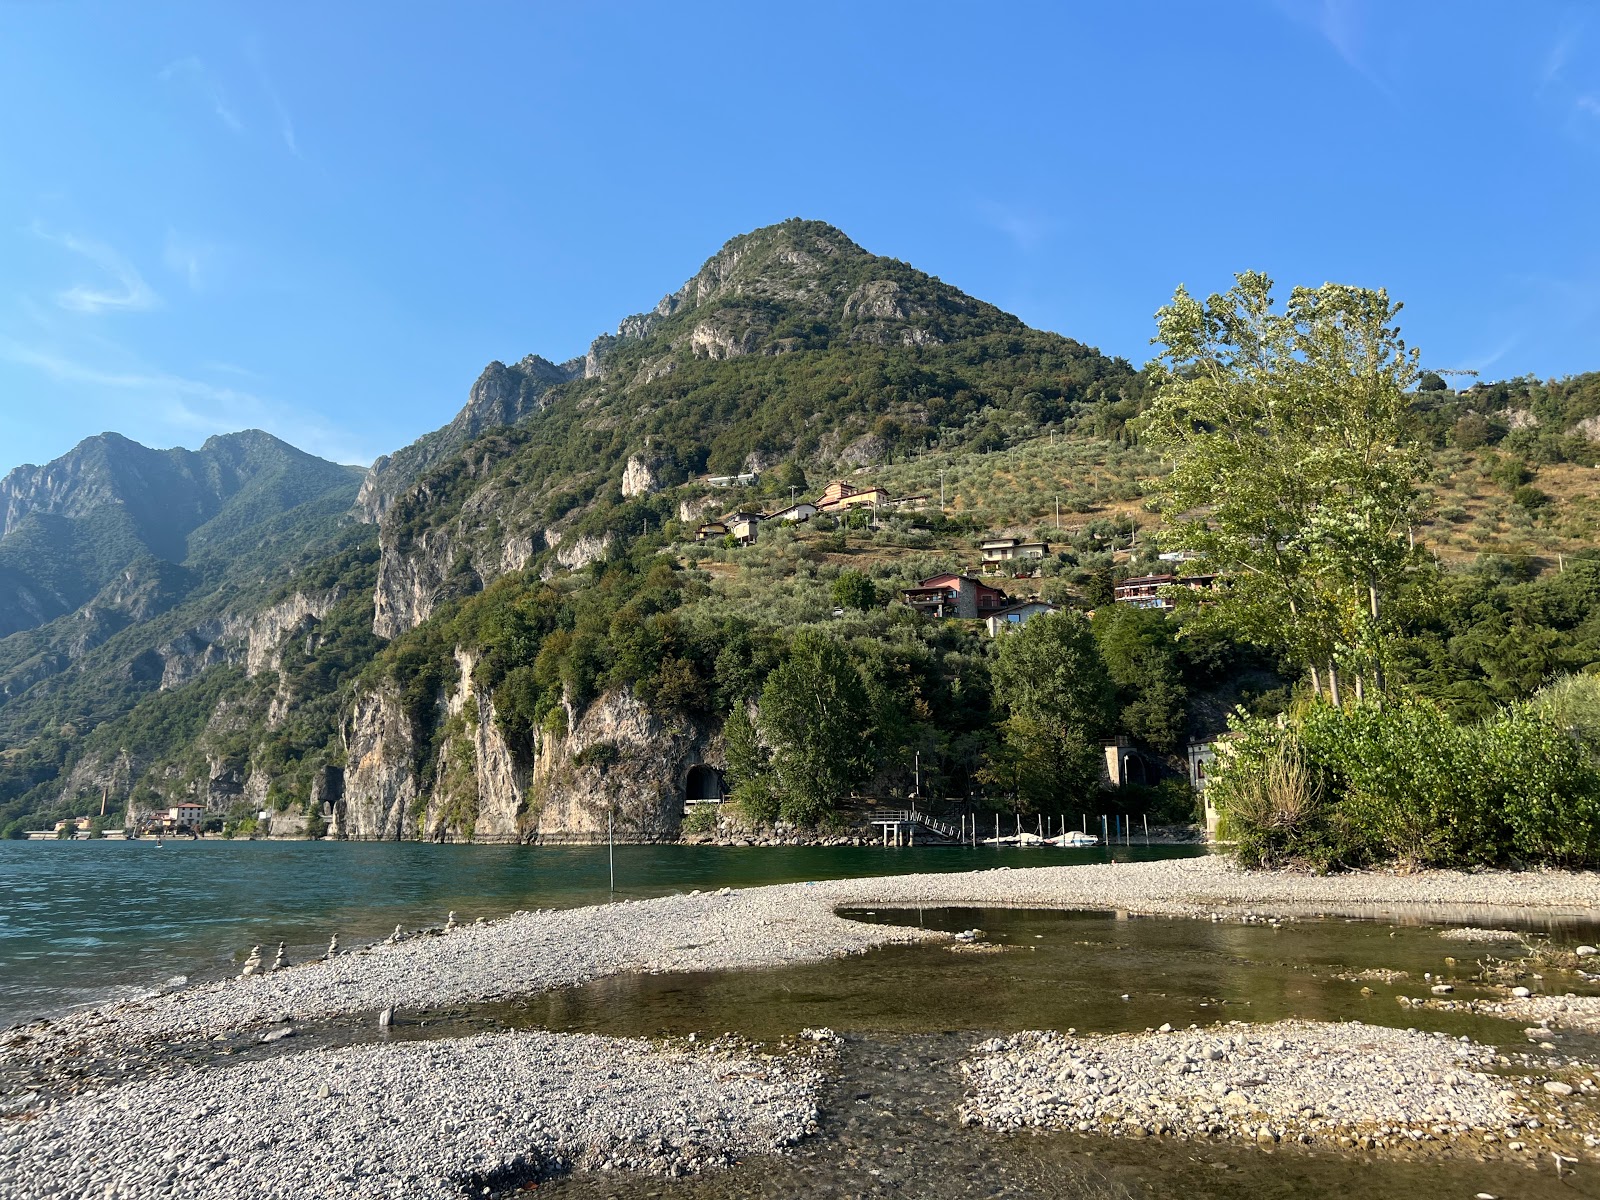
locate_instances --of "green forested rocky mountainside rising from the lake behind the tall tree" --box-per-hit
[0,221,1600,838]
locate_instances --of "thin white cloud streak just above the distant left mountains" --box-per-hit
[0,338,376,462]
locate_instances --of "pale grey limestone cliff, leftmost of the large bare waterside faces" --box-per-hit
[330,690,419,842]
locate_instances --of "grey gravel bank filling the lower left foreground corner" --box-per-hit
[0,1032,830,1200]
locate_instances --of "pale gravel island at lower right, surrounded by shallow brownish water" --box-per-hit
[962,1021,1597,1157]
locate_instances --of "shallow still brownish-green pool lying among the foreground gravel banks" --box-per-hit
[305,909,1600,1200]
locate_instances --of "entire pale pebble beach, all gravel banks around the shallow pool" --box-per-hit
[0,858,1600,1197]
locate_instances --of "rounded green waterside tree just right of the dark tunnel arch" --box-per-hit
[757,629,872,824]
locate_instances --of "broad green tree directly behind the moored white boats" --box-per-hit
[979,613,1115,811]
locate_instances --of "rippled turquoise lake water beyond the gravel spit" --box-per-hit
[0,842,1203,1029]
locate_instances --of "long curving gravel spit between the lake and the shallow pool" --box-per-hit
[9,856,1600,1078]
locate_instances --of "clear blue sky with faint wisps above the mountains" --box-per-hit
[0,0,1600,470]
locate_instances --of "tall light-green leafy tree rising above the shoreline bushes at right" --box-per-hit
[1146,272,1422,702]
